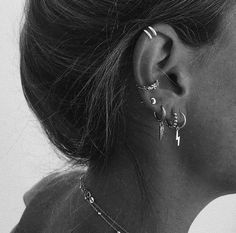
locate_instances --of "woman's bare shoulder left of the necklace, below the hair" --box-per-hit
[14,168,95,233]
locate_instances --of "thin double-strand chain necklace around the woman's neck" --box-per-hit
[80,175,129,233]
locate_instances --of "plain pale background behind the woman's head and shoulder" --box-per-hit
[0,0,236,233]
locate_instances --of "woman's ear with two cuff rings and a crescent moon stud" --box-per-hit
[133,25,193,117]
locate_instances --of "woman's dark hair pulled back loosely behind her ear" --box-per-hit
[20,0,228,167]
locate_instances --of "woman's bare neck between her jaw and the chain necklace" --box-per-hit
[84,118,219,233]
